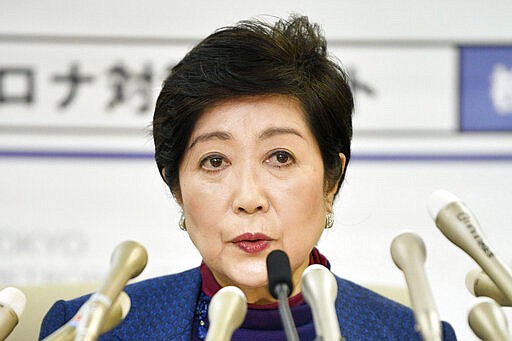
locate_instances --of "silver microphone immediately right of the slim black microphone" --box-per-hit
[301,264,343,341]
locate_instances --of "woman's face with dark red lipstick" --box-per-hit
[178,96,334,303]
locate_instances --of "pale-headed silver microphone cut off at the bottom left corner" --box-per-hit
[0,287,27,340]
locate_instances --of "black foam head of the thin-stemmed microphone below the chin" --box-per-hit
[267,250,293,299]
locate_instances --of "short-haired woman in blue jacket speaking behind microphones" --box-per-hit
[41,17,455,340]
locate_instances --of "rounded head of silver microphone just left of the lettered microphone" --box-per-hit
[391,232,427,271]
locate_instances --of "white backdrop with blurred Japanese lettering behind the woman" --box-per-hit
[0,0,512,340]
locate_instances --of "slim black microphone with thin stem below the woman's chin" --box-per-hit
[267,250,299,341]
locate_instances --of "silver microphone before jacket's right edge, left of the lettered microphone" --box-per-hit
[391,232,443,340]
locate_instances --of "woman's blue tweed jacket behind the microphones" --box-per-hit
[40,268,456,341]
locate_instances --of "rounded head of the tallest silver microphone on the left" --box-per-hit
[110,240,148,278]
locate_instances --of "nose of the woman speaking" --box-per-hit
[233,167,269,214]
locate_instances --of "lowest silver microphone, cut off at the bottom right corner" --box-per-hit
[468,297,512,341]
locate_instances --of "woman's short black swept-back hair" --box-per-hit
[153,15,354,196]
